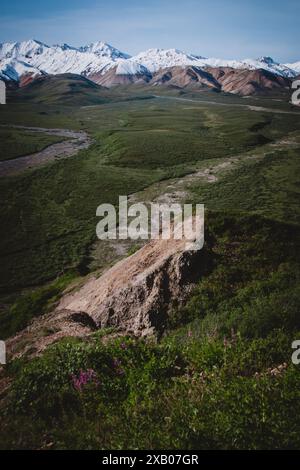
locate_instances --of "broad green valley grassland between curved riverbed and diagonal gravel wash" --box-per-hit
[0,94,299,292]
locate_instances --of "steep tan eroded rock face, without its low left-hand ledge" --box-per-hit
[58,240,203,336]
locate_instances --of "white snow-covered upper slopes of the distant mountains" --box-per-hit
[0,39,300,87]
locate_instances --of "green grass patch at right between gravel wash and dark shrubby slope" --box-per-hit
[190,148,300,224]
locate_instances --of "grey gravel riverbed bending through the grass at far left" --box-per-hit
[0,126,91,176]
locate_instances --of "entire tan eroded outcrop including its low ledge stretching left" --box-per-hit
[7,230,207,356]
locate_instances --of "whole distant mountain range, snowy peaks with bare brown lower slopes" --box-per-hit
[0,39,300,95]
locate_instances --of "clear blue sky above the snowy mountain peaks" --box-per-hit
[0,0,300,62]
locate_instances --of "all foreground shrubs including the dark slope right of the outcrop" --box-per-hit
[1,213,300,449]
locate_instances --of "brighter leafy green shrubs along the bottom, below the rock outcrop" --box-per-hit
[1,331,300,449]
